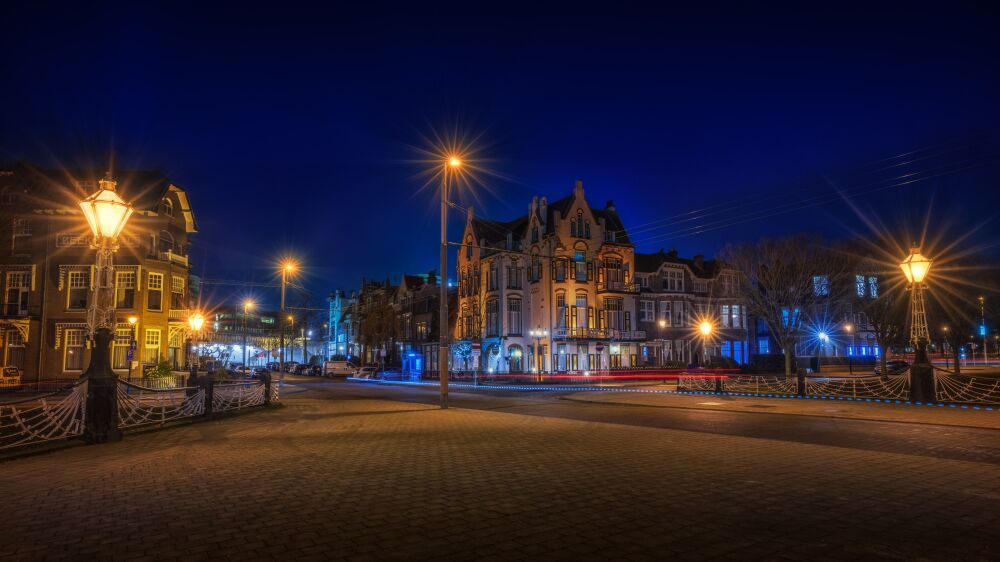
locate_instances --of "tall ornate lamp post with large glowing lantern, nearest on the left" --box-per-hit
[80,172,134,443]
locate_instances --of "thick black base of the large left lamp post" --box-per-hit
[81,328,122,444]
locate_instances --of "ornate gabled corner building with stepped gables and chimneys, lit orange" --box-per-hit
[451,181,646,372]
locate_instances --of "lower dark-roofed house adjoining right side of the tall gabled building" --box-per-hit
[635,250,750,366]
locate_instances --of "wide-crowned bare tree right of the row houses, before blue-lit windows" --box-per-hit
[721,235,848,384]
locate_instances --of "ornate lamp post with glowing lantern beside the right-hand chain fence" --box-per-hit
[904,248,936,402]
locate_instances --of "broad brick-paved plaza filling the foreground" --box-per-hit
[0,378,1000,560]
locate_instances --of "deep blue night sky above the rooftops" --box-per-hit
[0,2,1000,306]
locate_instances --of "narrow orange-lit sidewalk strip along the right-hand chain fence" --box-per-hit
[562,384,1000,429]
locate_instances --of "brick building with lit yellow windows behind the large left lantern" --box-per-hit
[0,163,198,381]
